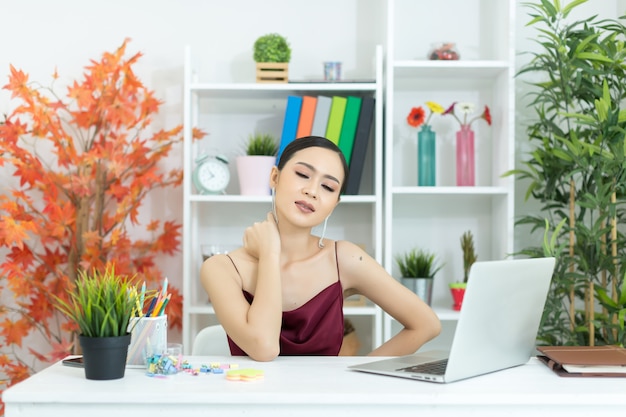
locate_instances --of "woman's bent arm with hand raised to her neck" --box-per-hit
[200,214,282,361]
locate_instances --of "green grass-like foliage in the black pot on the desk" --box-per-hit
[55,265,138,337]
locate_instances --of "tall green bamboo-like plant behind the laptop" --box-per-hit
[507,0,626,345]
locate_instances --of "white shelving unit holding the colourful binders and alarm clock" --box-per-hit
[183,46,383,353]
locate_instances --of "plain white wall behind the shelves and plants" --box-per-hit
[0,0,626,358]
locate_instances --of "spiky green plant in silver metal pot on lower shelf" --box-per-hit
[395,248,443,305]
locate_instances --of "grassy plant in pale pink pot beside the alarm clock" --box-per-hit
[236,132,278,195]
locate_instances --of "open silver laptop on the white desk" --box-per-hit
[348,258,555,383]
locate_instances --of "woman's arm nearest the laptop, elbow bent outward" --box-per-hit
[337,241,441,356]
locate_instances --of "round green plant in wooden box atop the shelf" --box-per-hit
[253,33,291,83]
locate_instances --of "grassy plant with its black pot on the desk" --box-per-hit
[55,265,139,380]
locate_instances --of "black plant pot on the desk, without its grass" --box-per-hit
[78,333,130,380]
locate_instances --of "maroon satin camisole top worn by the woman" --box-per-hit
[228,244,343,356]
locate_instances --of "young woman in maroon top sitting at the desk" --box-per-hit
[200,136,441,361]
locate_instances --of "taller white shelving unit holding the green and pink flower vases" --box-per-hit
[383,0,515,347]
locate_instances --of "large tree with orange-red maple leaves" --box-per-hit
[0,39,204,415]
